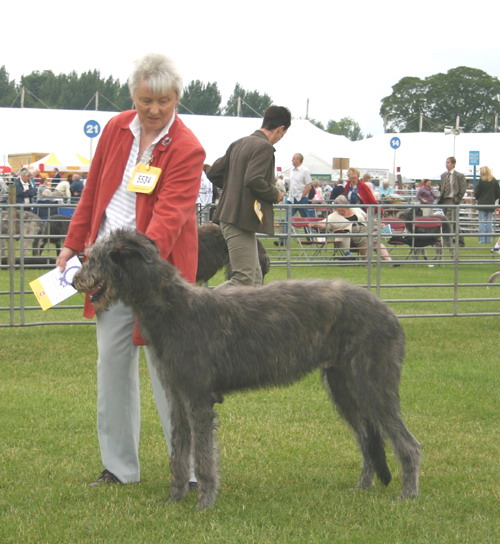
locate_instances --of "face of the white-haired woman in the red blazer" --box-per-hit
[132,81,179,133]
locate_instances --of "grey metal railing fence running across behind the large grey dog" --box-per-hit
[0,204,500,327]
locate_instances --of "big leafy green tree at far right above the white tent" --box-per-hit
[380,66,500,132]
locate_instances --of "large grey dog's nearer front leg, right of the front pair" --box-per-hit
[190,396,218,509]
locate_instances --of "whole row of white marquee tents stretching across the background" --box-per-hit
[0,108,500,179]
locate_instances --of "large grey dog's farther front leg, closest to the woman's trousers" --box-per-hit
[169,391,191,501]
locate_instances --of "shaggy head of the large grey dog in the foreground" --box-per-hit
[73,229,159,310]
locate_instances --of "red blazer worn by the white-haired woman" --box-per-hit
[64,110,205,334]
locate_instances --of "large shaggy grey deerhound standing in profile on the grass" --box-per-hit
[73,230,420,508]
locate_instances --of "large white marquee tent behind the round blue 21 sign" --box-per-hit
[0,108,351,178]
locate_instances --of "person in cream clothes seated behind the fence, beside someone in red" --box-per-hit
[313,195,399,266]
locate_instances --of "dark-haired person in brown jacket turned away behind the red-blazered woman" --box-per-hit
[207,106,291,288]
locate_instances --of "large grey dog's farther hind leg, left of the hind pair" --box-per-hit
[323,368,391,489]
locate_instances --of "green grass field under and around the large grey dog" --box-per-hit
[0,258,500,544]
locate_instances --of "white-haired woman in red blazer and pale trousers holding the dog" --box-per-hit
[57,54,205,486]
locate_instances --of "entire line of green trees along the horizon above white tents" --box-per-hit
[0,66,500,140]
